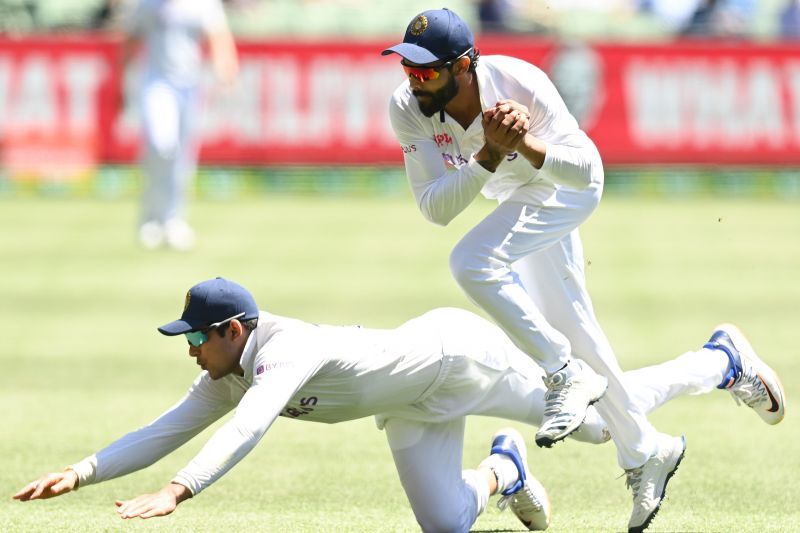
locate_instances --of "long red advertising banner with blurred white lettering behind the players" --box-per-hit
[0,36,800,168]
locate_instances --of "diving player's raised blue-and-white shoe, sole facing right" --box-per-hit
[703,324,784,425]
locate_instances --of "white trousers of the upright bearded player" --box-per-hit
[450,185,657,469]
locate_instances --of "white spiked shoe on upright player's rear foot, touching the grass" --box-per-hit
[625,434,686,533]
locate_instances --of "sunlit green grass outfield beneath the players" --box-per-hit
[0,195,800,532]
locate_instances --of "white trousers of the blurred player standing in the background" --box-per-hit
[139,78,199,223]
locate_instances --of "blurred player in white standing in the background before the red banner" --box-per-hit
[122,0,238,250]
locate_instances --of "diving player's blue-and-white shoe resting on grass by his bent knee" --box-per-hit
[490,428,550,531]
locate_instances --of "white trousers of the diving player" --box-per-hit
[376,309,727,533]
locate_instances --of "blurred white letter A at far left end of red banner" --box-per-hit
[9,54,58,132]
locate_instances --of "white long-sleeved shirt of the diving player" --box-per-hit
[71,309,527,494]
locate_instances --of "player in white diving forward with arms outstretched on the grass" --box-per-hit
[14,278,783,532]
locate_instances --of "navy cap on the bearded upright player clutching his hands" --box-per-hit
[381,9,475,65]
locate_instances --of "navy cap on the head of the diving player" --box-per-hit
[158,278,258,336]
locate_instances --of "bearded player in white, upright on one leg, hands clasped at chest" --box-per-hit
[383,9,776,531]
